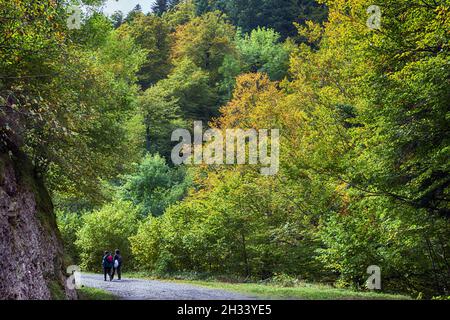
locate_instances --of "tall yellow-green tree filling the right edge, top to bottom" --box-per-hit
[284,1,449,296]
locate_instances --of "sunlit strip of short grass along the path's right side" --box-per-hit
[124,272,411,300]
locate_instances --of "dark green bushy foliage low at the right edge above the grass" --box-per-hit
[317,197,450,298]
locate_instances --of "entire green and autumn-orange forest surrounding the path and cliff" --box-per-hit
[0,0,450,298]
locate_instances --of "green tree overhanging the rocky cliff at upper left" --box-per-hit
[0,2,143,200]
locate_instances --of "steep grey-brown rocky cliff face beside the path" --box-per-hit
[0,150,76,299]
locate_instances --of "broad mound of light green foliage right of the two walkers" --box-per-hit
[131,169,326,279]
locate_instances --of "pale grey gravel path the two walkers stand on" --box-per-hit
[81,274,257,300]
